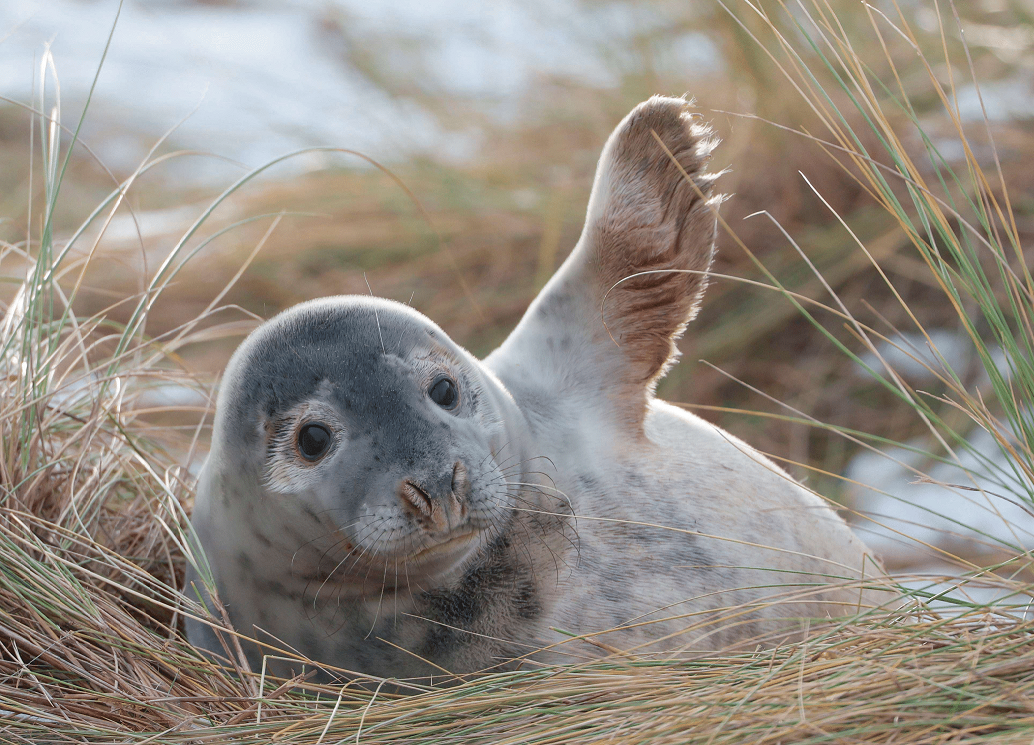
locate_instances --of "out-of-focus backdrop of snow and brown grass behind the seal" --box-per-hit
[0,0,1034,586]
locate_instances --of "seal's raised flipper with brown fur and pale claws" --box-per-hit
[485,96,720,431]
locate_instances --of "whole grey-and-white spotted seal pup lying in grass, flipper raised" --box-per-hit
[187,97,874,678]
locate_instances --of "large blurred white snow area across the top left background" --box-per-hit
[0,0,721,179]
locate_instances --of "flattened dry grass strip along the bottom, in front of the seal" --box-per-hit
[6,582,1034,745]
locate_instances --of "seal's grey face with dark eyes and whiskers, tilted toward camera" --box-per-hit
[215,298,521,588]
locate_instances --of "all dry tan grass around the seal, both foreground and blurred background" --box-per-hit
[0,0,1034,745]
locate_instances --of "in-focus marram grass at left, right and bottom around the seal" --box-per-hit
[0,0,1034,745]
